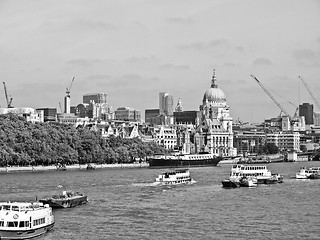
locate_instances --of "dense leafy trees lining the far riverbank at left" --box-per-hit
[0,114,165,167]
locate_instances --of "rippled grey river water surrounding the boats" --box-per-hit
[0,162,320,240]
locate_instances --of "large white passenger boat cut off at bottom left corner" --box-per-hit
[0,202,55,240]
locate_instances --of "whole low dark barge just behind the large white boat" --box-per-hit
[39,191,88,208]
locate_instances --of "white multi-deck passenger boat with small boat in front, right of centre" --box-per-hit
[222,164,283,186]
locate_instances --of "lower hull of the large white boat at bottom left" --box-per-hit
[0,222,54,240]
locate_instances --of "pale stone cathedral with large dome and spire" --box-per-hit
[194,71,236,156]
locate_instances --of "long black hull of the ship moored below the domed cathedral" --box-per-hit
[149,157,221,168]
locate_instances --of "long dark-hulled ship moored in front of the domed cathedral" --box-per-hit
[148,153,222,167]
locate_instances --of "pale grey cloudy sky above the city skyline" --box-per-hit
[0,0,320,122]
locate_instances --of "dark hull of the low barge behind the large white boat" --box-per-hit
[39,196,88,208]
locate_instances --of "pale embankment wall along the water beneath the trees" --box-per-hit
[0,162,149,173]
